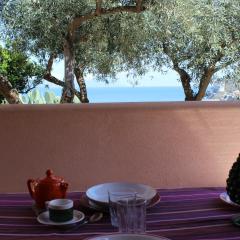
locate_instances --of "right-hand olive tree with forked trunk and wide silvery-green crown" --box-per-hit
[108,0,240,101]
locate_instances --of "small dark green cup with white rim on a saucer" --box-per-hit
[47,199,73,222]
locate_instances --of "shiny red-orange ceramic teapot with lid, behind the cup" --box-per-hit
[27,169,68,209]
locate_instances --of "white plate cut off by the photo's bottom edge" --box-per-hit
[88,234,169,240]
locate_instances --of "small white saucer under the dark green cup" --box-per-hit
[37,210,85,226]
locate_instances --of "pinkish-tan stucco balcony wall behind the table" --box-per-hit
[0,102,240,192]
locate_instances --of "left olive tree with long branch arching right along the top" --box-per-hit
[3,0,153,103]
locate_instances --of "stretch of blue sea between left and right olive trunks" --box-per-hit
[78,87,184,103]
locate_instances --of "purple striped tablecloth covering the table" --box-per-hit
[0,188,240,240]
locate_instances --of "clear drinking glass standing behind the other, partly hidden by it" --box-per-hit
[108,190,136,227]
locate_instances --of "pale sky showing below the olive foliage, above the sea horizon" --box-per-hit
[45,61,181,88]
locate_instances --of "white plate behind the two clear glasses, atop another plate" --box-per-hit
[86,182,157,204]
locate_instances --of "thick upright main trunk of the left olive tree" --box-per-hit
[61,38,75,103]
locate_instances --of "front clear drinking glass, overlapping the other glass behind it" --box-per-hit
[116,196,146,233]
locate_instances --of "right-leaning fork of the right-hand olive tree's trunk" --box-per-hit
[196,68,215,101]
